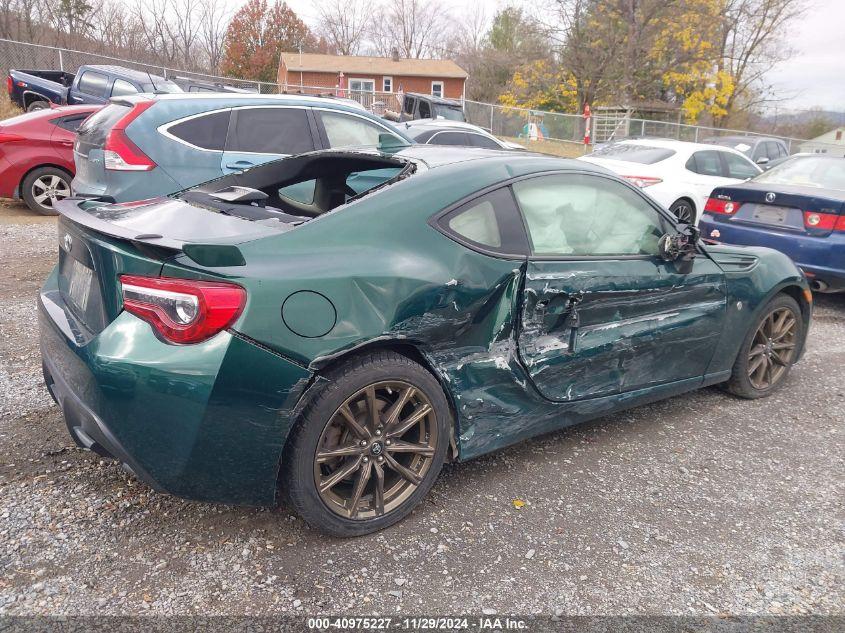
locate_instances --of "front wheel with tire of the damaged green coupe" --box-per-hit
[726,294,806,399]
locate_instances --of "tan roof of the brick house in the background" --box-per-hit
[282,53,468,79]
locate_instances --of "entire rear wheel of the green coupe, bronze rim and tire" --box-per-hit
[281,351,450,536]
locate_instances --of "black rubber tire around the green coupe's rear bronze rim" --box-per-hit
[280,350,451,537]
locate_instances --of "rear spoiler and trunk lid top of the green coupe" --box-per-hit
[54,197,260,267]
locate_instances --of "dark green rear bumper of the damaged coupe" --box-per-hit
[38,266,311,505]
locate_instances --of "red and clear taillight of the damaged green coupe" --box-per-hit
[120,275,246,345]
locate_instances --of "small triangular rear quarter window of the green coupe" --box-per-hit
[438,187,527,255]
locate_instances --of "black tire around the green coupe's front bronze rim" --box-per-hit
[724,294,806,400]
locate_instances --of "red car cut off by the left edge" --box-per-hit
[0,104,102,215]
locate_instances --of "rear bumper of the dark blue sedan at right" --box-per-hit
[699,213,845,290]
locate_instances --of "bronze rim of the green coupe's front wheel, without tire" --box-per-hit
[748,308,798,390]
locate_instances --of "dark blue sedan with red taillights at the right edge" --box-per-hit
[700,155,845,292]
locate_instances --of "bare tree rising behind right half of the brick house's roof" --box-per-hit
[370,0,448,58]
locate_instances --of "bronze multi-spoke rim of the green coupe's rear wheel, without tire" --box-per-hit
[314,381,439,519]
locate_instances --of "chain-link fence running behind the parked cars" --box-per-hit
[0,38,845,156]
